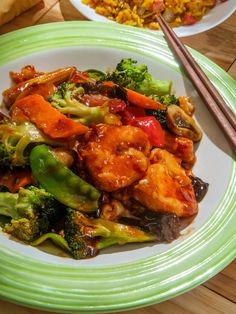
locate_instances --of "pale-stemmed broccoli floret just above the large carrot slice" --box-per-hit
[48,81,109,125]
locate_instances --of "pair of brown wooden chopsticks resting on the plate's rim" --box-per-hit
[157,15,236,154]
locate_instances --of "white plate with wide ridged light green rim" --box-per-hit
[0,22,236,313]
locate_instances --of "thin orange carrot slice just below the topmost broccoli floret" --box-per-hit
[103,81,166,110]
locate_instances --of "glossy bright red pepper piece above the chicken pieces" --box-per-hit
[129,117,165,147]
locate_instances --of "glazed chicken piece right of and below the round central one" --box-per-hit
[133,148,198,217]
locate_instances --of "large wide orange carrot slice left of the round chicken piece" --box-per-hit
[12,94,88,139]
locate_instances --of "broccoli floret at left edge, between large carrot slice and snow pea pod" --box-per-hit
[0,121,65,168]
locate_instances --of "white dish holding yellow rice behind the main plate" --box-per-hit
[70,0,236,37]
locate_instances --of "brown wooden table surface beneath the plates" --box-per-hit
[0,0,236,314]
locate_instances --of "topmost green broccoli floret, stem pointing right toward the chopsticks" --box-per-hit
[106,58,171,96]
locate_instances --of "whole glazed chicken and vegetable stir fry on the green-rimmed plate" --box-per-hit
[0,59,208,259]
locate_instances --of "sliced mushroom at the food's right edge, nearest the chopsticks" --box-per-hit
[166,105,202,142]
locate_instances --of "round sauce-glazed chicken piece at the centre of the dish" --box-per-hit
[80,124,151,192]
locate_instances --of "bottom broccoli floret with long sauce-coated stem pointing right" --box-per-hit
[64,209,156,259]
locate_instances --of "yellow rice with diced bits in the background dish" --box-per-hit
[82,0,216,29]
